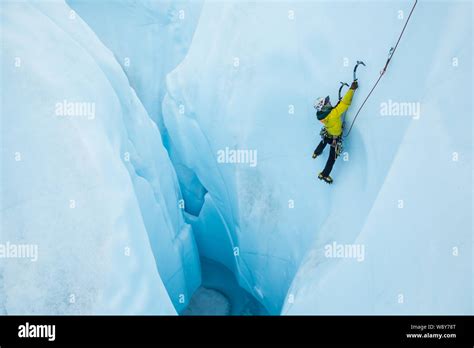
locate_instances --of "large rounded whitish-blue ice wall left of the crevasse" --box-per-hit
[0,1,200,314]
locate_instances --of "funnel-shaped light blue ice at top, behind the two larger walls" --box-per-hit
[67,0,202,130]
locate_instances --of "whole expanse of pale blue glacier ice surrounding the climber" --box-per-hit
[0,0,473,315]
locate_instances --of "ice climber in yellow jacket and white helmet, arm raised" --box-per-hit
[313,81,358,184]
